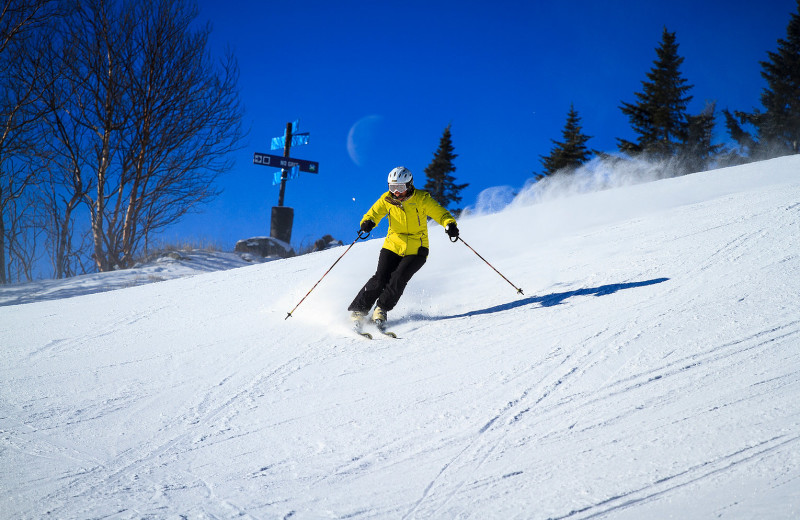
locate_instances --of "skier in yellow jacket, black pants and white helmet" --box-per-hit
[347,166,458,331]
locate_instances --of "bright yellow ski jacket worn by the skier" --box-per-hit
[361,189,456,256]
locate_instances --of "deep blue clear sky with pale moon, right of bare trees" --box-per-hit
[172,0,797,250]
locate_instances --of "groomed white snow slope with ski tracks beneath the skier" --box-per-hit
[0,156,800,519]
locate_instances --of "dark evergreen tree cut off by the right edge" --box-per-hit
[724,0,800,159]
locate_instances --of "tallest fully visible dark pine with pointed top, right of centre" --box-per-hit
[617,27,692,158]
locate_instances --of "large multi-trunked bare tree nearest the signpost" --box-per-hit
[41,0,242,271]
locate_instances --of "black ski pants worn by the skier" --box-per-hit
[347,247,428,313]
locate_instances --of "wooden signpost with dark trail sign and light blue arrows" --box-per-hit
[253,122,319,244]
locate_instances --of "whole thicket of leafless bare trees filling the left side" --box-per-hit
[0,0,243,283]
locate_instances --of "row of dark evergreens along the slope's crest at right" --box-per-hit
[534,0,800,179]
